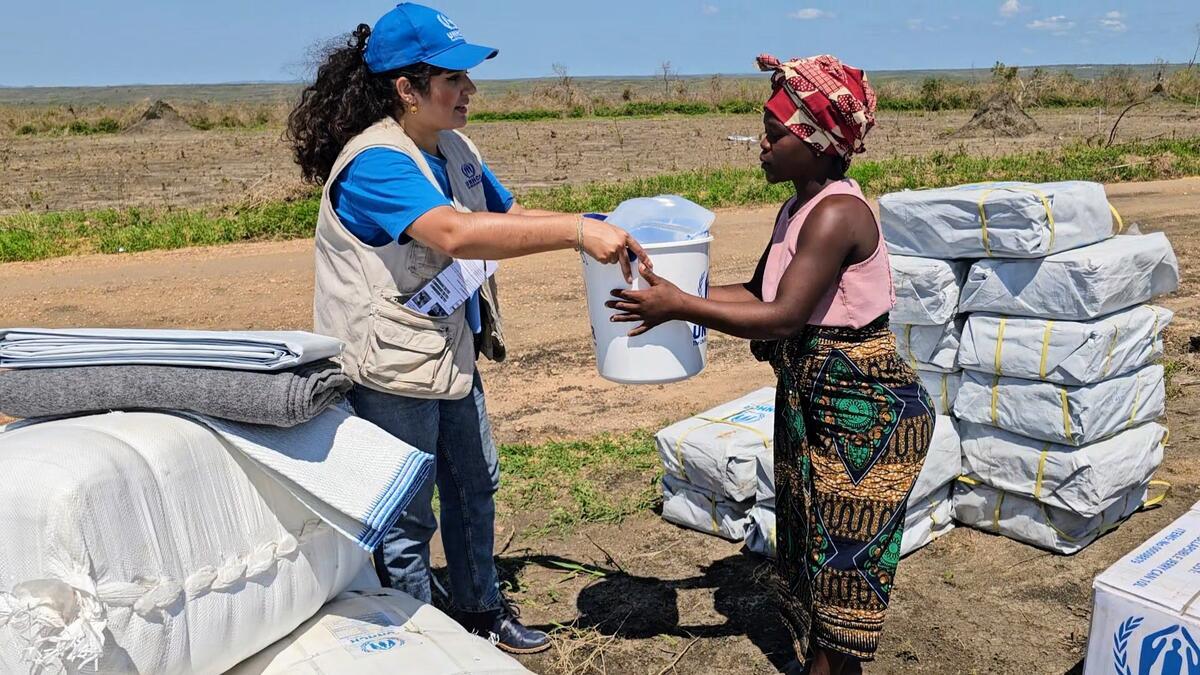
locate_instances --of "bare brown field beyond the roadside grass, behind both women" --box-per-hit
[0,104,1200,214]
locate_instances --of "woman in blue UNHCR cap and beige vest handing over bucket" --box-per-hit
[288,2,646,652]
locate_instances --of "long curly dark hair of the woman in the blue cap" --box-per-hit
[284,24,448,185]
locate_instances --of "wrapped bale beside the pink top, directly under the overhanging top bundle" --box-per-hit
[889,256,971,325]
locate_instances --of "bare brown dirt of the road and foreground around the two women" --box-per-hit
[0,176,1200,674]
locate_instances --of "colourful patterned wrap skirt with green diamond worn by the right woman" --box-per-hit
[751,315,935,661]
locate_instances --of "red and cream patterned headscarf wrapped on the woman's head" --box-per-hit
[758,54,875,162]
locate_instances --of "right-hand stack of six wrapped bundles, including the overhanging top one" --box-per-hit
[880,181,1178,552]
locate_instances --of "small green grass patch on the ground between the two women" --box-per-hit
[497,431,661,533]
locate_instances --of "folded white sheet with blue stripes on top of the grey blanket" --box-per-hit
[0,328,342,370]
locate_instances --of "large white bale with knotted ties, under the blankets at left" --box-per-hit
[0,413,367,674]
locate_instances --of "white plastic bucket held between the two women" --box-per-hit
[582,237,713,384]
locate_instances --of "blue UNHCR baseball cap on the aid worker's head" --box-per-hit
[364,2,499,73]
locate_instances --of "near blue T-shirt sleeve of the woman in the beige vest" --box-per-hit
[330,148,450,246]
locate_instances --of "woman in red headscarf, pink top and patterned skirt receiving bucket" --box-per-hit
[608,55,934,675]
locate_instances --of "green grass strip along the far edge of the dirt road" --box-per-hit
[0,137,1200,262]
